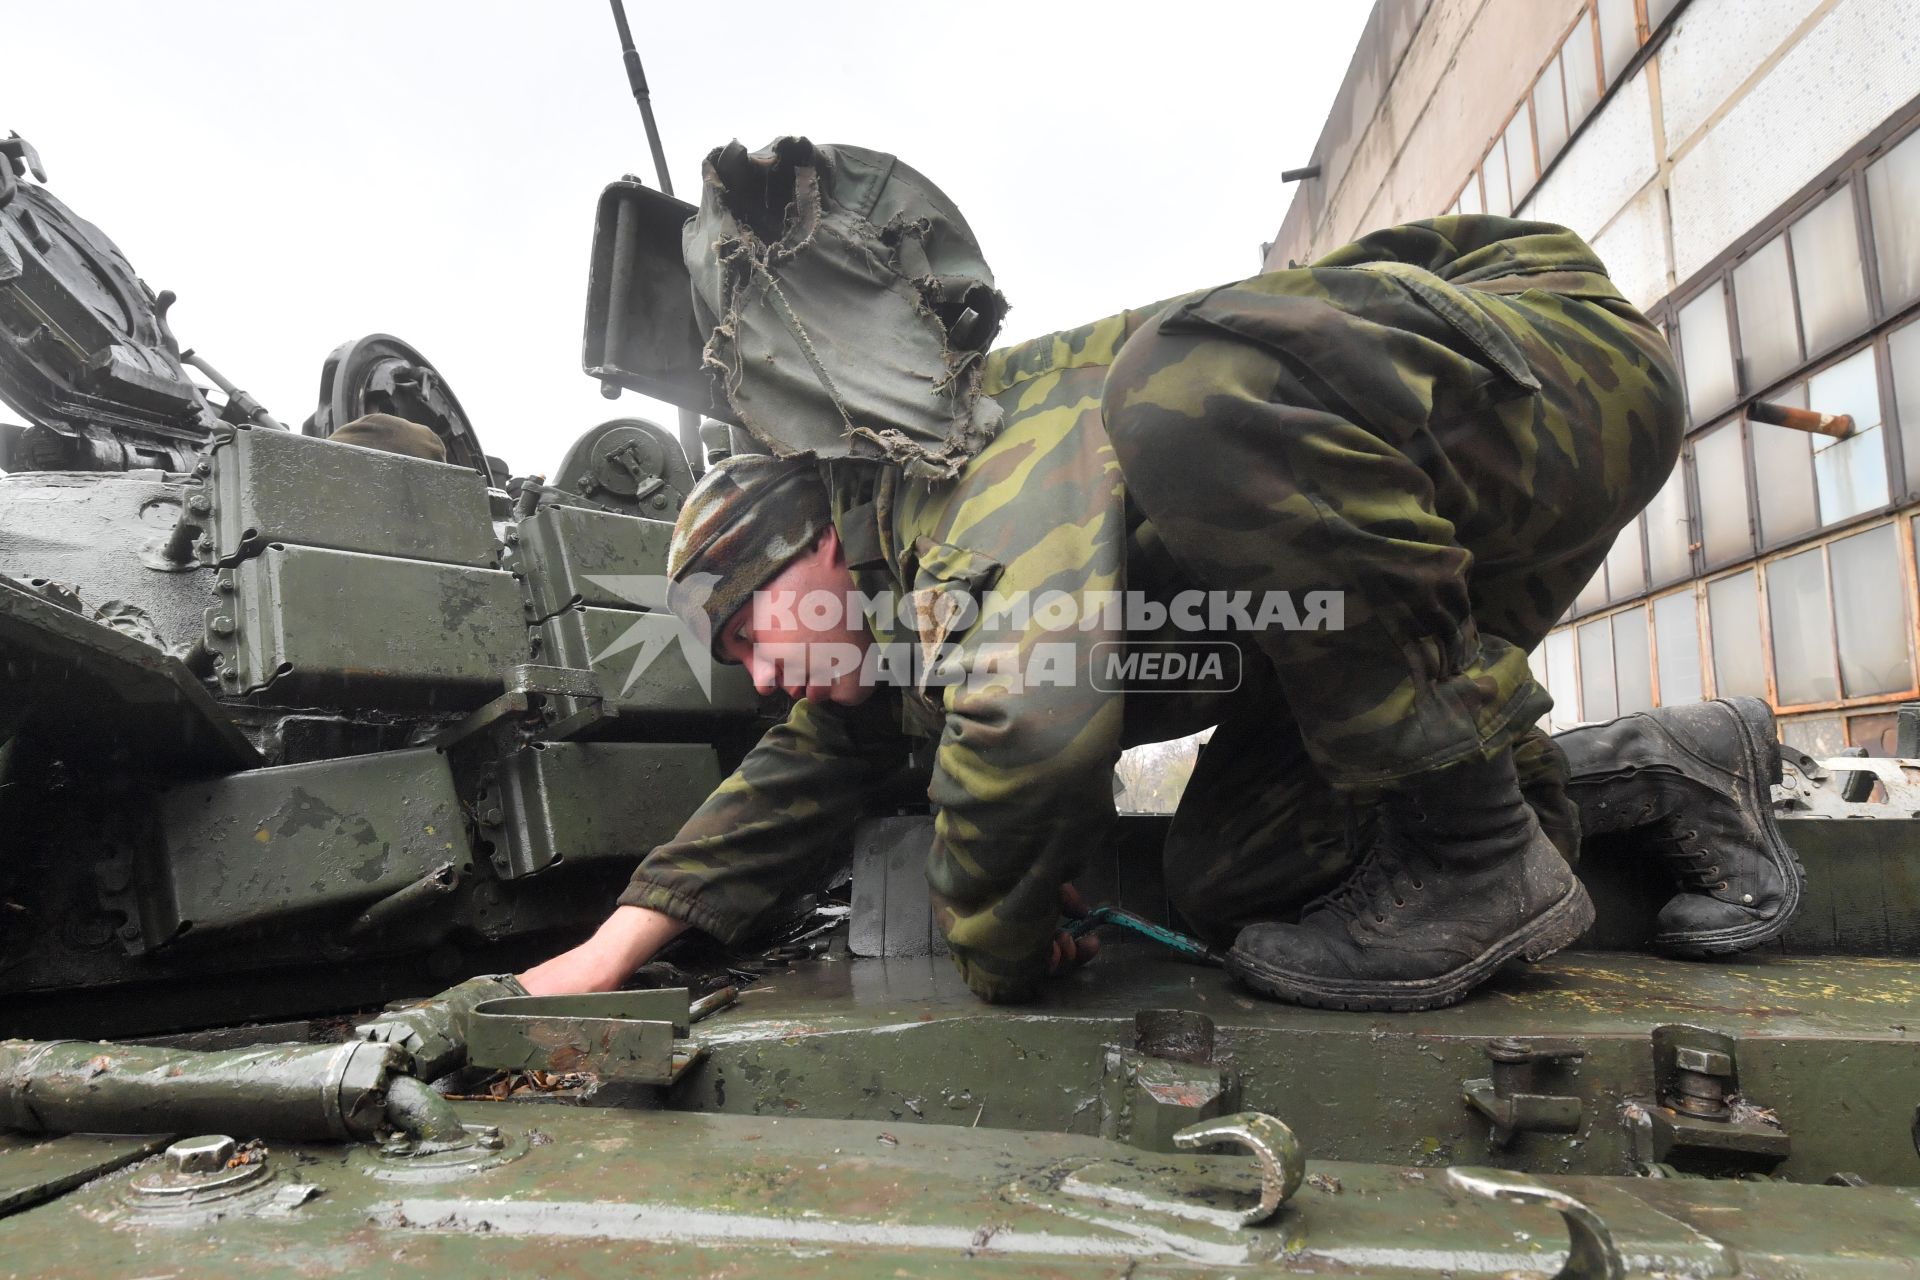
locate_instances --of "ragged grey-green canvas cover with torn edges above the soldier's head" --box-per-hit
[682,138,1006,480]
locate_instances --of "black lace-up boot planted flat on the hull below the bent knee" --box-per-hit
[1227,752,1594,1009]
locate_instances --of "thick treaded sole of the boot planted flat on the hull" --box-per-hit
[1227,881,1594,1013]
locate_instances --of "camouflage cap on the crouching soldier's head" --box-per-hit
[666,453,831,662]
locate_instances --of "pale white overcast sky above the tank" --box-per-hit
[0,0,1369,472]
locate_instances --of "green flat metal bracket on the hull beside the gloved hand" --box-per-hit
[467,986,707,1084]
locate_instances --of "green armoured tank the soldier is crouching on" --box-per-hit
[0,140,1920,1278]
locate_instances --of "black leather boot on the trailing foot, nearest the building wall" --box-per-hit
[1553,699,1807,956]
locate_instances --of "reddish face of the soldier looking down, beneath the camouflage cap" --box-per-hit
[720,526,874,706]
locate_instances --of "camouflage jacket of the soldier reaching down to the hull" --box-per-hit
[620,219,1635,1000]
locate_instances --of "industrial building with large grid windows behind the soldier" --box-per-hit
[1265,0,1920,754]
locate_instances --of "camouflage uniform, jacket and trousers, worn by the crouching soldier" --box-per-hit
[622,217,1682,1000]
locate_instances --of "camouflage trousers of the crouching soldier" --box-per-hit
[1102,237,1684,940]
